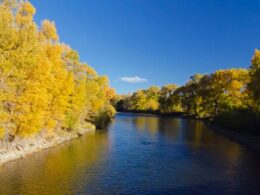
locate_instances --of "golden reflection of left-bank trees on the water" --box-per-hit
[0,133,109,194]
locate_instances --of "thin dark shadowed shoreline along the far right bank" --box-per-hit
[118,111,260,153]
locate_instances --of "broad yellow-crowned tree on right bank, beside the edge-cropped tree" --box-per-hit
[201,69,248,116]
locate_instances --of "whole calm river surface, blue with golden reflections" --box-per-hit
[0,114,260,195]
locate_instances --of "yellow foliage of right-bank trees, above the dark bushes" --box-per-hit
[118,65,254,117]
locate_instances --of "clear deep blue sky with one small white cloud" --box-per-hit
[31,0,260,94]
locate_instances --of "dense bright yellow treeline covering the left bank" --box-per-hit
[0,0,114,140]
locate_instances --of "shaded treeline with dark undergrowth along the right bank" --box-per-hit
[114,50,260,132]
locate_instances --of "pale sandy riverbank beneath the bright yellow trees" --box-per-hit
[0,124,95,166]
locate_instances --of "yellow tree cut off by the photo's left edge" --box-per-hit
[0,1,18,138]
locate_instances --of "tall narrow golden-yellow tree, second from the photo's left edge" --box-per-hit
[9,1,47,136]
